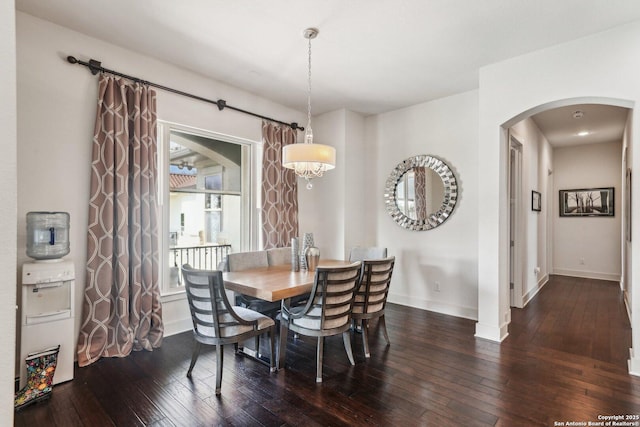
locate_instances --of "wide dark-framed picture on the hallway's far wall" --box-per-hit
[559,187,615,217]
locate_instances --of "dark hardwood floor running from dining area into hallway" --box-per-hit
[15,276,640,427]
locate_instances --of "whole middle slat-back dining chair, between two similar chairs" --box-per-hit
[278,261,362,382]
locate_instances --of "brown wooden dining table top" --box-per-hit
[222,259,351,301]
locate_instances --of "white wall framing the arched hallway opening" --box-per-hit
[476,17,640,373]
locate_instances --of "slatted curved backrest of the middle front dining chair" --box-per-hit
[293,261,362,331]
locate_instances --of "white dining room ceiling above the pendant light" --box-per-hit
[16,0,640,145]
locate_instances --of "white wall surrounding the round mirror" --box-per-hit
[365,91,478,319]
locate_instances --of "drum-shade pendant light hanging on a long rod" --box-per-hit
[282,28,336,190]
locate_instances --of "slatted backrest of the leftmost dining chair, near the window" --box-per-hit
[182,264,254,339]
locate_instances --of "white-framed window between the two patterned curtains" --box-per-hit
[158,122,255,294]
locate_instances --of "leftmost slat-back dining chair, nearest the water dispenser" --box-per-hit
[182,264,276,395]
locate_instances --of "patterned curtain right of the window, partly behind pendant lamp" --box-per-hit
[262,121,298,249]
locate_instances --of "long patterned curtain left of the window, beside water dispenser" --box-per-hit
[78,74,163,366]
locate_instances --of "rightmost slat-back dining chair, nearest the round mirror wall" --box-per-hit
[352,256,396,357]
